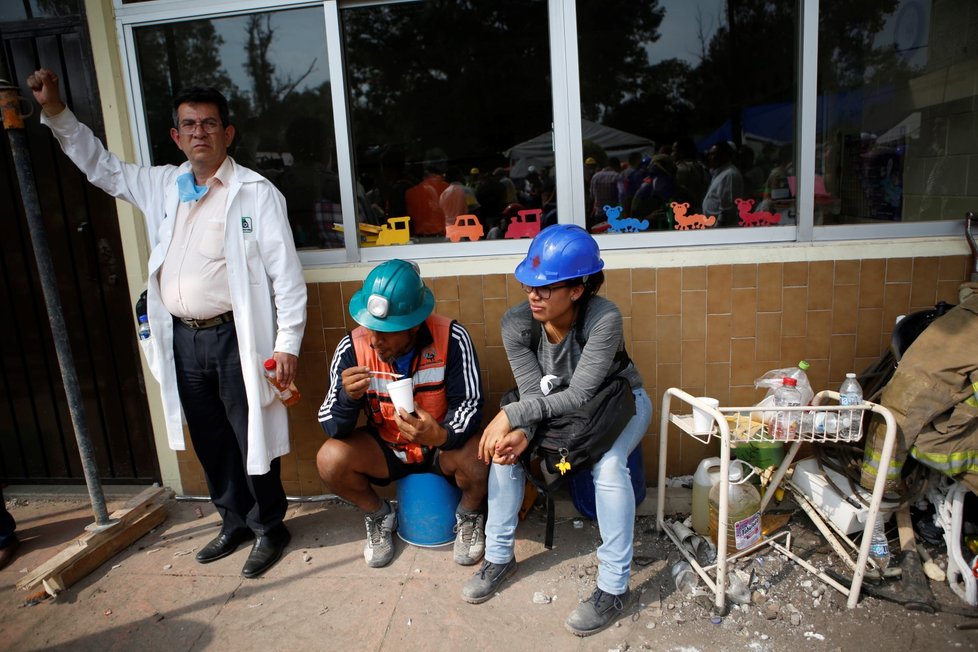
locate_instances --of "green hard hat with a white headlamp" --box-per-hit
[350,260,435,333]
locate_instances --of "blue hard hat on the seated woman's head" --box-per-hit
[516,224,604,287]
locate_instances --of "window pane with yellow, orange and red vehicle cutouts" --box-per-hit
[341,0,557,246]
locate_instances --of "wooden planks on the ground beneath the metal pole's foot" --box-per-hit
[17,487,169,589]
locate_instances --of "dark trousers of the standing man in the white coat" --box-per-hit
[173,319,288,535]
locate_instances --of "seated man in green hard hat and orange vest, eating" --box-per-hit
[316,260,488,568]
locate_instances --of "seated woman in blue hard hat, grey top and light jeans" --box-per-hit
[462,224,652,636]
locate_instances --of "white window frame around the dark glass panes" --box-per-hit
[113,0,964,268]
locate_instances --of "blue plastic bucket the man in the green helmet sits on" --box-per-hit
[397,473,462,548]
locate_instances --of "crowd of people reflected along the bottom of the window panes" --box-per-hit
[308,137,794,246]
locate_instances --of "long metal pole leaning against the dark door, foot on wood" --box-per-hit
[0,71,112,528]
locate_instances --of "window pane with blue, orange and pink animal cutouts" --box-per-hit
[577,0,798,233]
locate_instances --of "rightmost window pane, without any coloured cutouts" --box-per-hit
[815,0,978,224]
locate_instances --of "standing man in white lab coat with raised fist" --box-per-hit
[28,69,306,577]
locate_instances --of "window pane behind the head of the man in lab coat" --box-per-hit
[134,7,343,249]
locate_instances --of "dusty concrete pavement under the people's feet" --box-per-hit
[0,487,978,652]
